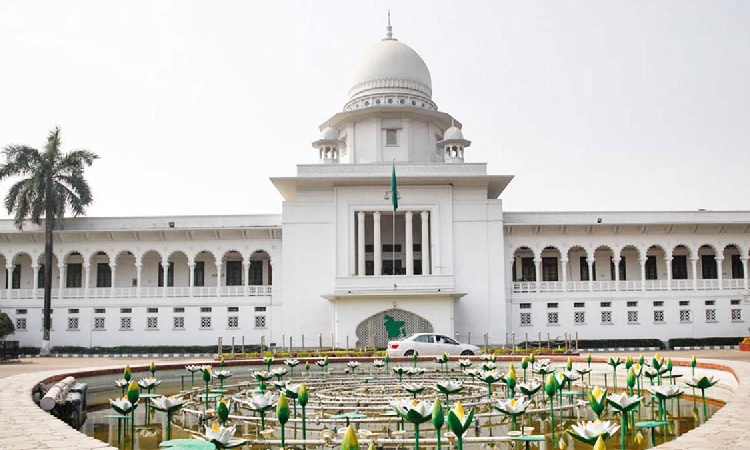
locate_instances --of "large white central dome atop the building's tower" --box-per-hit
[349,38,432,101]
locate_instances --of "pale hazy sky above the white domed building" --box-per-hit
[0,0,750,218]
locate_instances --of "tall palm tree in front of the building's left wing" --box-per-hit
[0,127,99,355]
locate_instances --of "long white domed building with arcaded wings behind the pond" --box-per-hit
[0,27,750,347]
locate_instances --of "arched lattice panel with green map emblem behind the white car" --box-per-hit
[356,309,434,348]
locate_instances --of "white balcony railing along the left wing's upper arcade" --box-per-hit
[0,286,273,300]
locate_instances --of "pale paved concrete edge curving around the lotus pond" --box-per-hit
[0,357,750,450]
